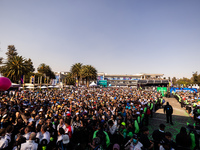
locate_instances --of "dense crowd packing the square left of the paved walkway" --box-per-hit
[0,87,198,150]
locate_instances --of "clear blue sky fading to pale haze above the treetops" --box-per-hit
[0,0,200,78]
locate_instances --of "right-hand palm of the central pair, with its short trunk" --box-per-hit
[81,65,97,87]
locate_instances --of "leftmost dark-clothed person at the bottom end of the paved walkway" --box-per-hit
[140,127,154,150]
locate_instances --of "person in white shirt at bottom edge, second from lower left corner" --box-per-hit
[21,132,38,150]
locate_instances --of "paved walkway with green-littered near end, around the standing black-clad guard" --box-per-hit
[148,98,194,140]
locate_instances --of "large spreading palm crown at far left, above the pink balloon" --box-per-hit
[1,56,34,83]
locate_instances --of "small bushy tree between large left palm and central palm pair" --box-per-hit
[37,63,55,79]
